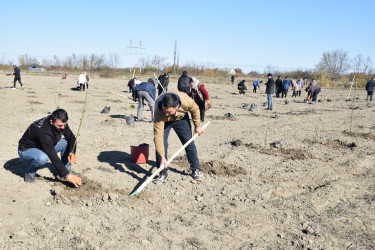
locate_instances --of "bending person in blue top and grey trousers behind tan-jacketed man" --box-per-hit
[133,78,156,122]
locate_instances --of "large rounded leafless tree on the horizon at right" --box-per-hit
[316,50,350,79]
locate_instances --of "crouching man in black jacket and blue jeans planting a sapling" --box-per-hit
[18,109,82,187]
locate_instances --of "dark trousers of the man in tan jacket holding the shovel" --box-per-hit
[156,113,199,174]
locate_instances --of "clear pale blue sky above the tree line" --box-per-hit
[0,0,375,72]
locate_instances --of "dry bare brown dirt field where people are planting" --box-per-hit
[0,74,375,249]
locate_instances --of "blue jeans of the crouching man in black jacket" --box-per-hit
[18,138,70,175]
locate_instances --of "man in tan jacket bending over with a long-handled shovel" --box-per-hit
[153,92,203,184]
